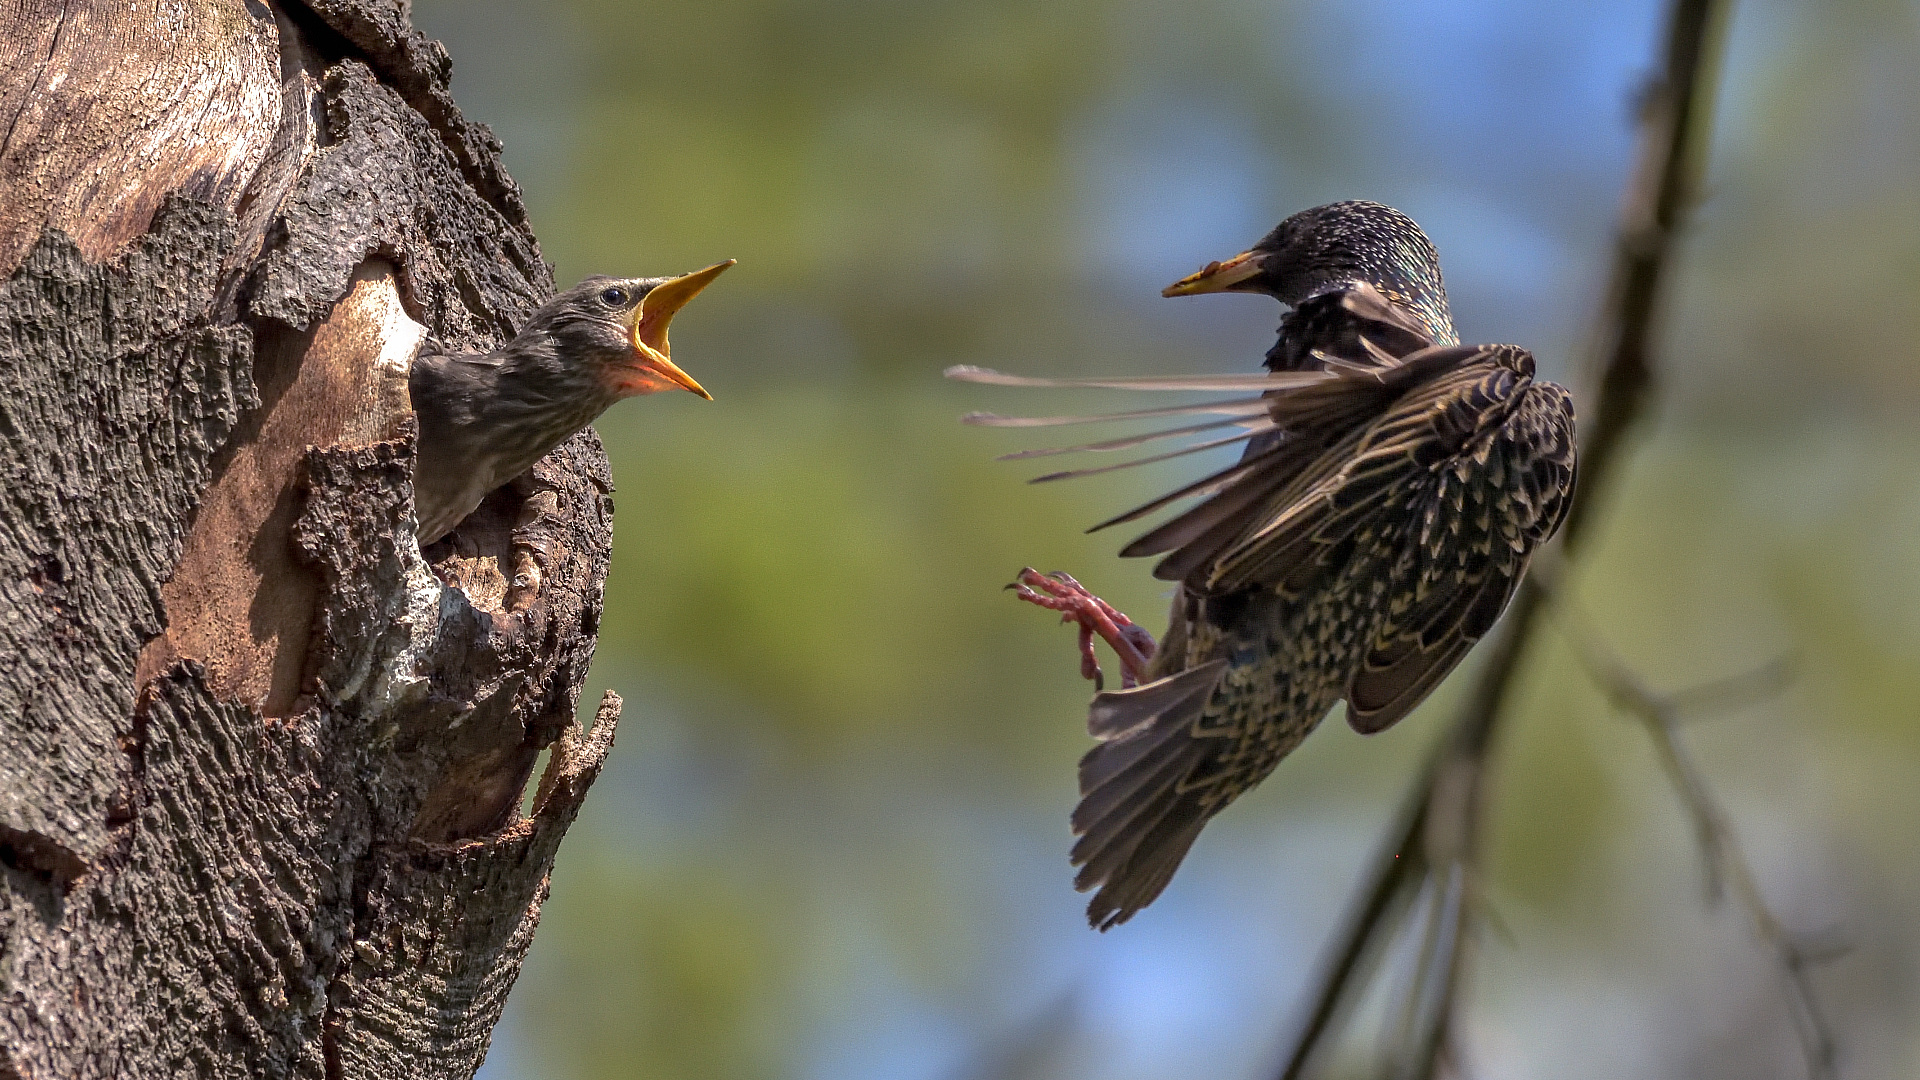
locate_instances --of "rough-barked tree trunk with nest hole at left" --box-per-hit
[0,0,618,1080]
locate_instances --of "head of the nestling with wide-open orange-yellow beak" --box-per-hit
[515,259,733,400]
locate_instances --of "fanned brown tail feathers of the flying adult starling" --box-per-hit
[1073,659,1227,930]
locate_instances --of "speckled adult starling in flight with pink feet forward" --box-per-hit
[948,202,1574,930]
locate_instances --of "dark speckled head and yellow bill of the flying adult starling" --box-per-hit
[1162,200,1452,340]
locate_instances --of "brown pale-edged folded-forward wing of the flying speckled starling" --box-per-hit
[1123,346,1574,732]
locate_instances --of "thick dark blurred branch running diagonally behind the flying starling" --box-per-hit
[1281,0,1730,1080]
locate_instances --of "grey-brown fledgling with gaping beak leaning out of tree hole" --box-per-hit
[407,259,733,546]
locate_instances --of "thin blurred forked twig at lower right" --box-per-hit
[1555,600,1834,1078]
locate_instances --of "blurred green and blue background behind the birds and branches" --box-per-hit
[415,0,1920,1080]
